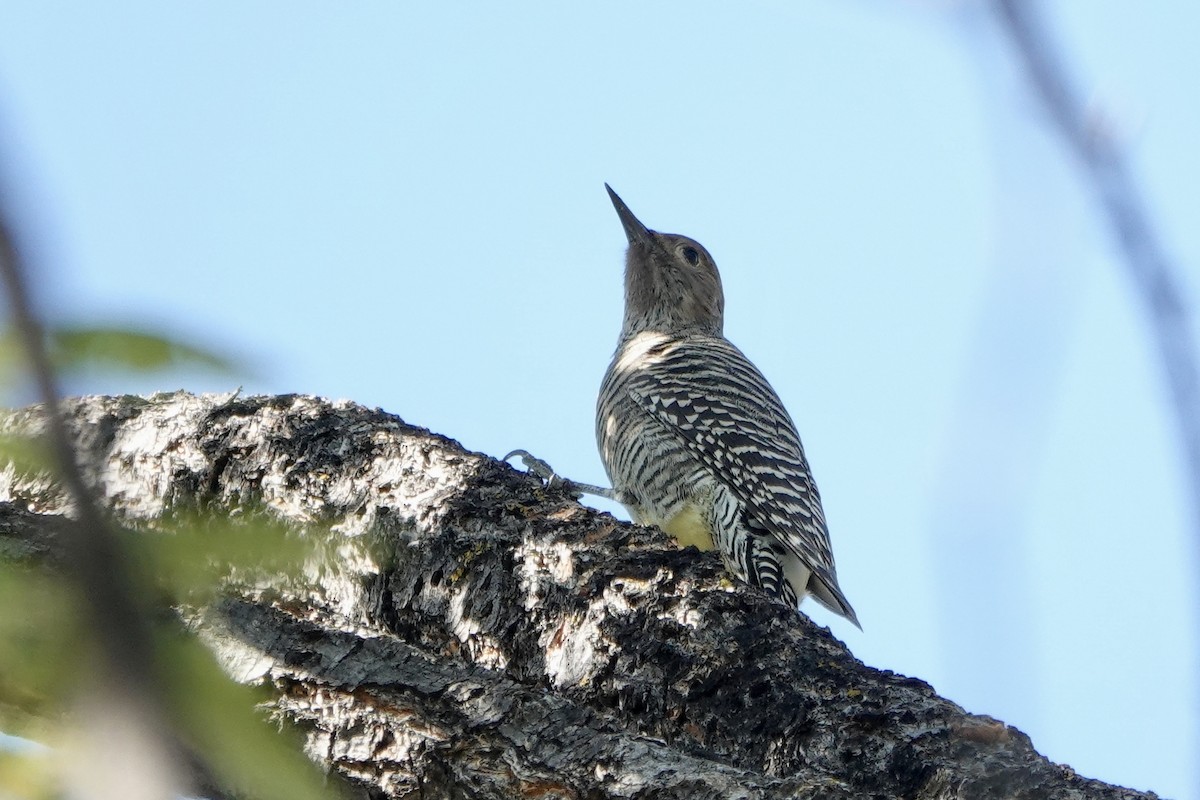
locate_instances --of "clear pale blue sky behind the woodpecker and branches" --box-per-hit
[0,0,1200,800]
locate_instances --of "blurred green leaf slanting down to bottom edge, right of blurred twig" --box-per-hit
[160,633,340,800]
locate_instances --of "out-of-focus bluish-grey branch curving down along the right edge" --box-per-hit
[995,0,1200,546]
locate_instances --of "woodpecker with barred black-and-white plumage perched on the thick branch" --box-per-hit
[588,184,862,630]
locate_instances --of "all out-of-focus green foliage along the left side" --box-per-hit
[0,327,345,800]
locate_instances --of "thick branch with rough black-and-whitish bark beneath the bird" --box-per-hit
[0,393,1153,800]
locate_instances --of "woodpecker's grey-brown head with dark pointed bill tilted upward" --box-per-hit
[605,184,725,337]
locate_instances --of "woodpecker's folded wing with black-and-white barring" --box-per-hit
[628,338,840,582]
